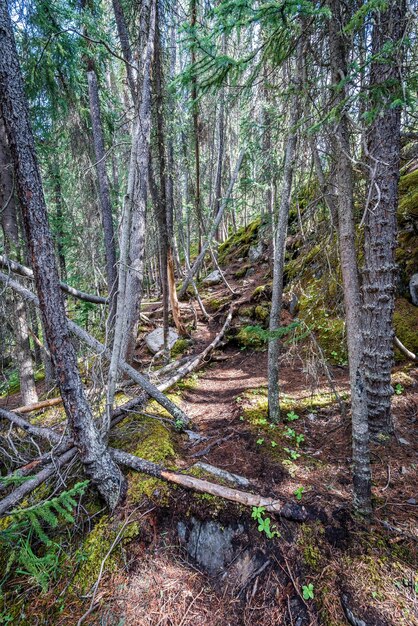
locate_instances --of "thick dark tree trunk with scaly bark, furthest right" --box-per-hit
[363,0,406,438]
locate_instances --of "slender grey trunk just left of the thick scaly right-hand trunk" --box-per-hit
[329,0,371,515]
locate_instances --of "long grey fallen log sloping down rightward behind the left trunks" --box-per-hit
[0,272,189,427]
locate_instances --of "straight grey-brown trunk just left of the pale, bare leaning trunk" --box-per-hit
[87,64,117,328]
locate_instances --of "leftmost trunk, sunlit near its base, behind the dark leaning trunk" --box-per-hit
[0,116,38,404]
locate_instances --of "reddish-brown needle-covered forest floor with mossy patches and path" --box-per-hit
[0,258,418,626]
